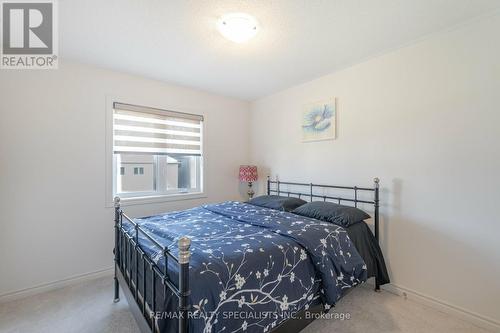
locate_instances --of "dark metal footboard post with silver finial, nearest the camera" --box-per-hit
[178,236,191,332]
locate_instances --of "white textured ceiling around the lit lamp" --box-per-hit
[59,0,500,100]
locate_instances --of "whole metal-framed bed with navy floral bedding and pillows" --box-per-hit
[114,179,389,333]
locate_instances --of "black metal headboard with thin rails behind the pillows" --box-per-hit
[267,176,380,242]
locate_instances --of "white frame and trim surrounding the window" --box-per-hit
[105,96,207,207]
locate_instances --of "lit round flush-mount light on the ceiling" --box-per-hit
[217,13,258,43]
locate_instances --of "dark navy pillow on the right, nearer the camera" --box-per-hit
[292,201,370,227]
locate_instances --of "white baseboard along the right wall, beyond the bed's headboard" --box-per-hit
[381,283,500,332]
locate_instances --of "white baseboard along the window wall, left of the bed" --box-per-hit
[0,267,113,303]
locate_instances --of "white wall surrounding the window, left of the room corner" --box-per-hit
[0,63,249,295]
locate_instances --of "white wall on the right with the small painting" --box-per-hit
[251,16,500,327]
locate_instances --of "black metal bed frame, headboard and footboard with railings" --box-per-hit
[113,176,380,333]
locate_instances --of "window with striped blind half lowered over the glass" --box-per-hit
[113,103,203,198]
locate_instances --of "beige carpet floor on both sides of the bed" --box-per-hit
[0,277,489,333]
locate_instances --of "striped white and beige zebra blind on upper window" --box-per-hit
[113,103,203,156]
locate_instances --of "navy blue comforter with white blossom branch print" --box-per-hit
[124,201,367,332]
